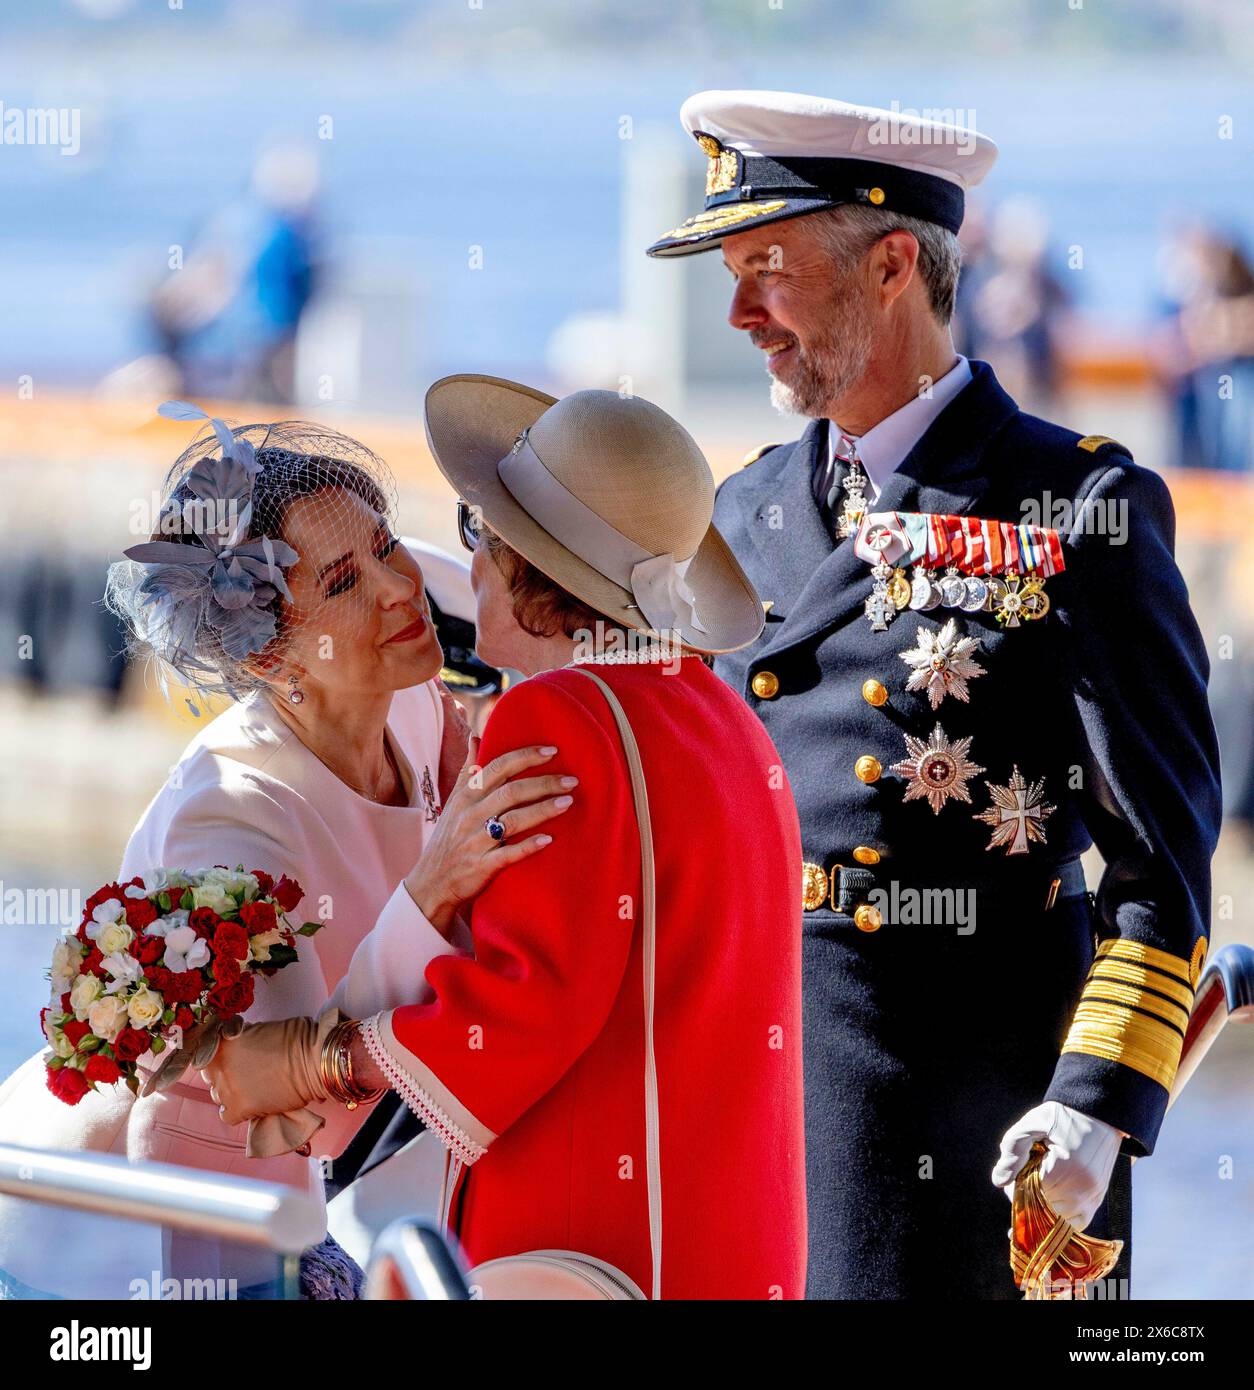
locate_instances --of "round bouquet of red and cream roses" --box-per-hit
[40,865,323,1105]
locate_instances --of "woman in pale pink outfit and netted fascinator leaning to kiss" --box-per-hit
[0,407,570,1297]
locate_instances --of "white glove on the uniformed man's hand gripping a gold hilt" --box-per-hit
[993,1101,1125,1230]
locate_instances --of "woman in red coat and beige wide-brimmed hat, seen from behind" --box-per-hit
[209,377,805,1298]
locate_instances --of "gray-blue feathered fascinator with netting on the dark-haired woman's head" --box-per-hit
[106,400,396,699]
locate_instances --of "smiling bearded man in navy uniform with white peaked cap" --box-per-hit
[649,92,1219,1298]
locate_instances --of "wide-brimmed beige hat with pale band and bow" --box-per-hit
[424,375,765,653]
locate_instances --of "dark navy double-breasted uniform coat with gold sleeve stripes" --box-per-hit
[715,361,1221,1298]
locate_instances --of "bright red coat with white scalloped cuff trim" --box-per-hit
[385,657,806,1298]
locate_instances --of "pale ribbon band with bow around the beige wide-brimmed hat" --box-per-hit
[496,430,708,632]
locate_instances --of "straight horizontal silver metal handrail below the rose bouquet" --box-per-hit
[0,1144,327,1255]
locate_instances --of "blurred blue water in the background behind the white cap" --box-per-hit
[0,43,1254,382]
